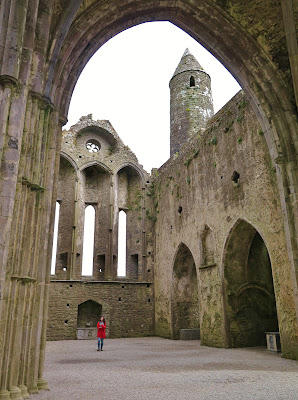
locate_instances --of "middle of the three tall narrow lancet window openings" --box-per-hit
[82,205,95,276]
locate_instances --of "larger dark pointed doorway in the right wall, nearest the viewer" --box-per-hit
[224,220,278,347]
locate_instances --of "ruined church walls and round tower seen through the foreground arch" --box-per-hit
[47,49,292,347]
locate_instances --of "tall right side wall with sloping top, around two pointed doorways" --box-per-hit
[154,92,297,357]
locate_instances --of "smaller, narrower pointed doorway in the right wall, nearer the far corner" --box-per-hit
[172,243,200,339]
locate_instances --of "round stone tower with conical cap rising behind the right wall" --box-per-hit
[170,49,213,156]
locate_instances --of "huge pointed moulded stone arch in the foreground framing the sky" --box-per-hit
[44,4,298,315]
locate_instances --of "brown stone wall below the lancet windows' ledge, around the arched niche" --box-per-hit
[47,281,154,340]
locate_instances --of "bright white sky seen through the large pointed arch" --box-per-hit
[64,22,240,172]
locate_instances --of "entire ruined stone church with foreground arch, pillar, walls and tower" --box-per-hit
[0,0,298,399]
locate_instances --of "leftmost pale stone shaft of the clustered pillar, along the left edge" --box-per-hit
[0,82,28,399]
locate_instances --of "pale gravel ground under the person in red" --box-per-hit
[30,337,298,400]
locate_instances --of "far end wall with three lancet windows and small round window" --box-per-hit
[47,115,154,340]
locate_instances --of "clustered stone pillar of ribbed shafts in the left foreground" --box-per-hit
[0,84,60,399]
